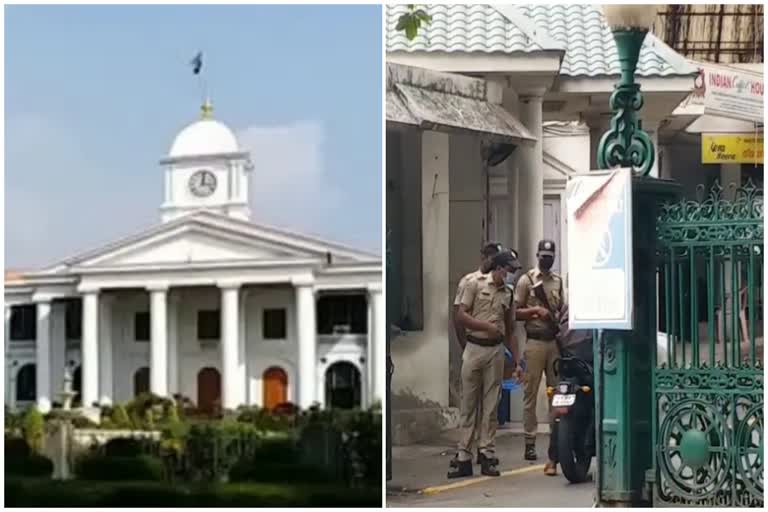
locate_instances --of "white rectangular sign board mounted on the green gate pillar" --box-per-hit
[566,169,633,330]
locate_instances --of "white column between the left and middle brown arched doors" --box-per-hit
[149,286,168,396]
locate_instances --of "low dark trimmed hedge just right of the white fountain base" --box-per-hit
[75,455,163,481]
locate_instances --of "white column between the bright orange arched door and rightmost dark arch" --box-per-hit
[293,278,317,409]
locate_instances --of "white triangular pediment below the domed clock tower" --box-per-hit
[44,211,377,273]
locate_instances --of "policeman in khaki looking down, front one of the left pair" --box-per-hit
[448,252,517,478]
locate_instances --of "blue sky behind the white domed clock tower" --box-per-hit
[5,5,382,269]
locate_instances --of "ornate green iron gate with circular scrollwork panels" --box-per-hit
[649,178,764,507]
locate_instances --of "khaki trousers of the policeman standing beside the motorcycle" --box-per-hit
[523,338,560,444]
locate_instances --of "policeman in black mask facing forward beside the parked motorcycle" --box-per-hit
[515,240,565,476]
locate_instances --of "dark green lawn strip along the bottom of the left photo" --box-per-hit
[5,477,382,508]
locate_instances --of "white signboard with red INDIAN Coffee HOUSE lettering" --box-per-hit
[691,62,763,123]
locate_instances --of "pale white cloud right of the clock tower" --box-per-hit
[238,121,341,239]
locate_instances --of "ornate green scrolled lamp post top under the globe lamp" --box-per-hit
[597,29,656,176]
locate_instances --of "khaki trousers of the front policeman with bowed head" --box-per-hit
[457,343,504,461]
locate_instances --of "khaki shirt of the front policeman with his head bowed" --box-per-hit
[461,274,514,339]
